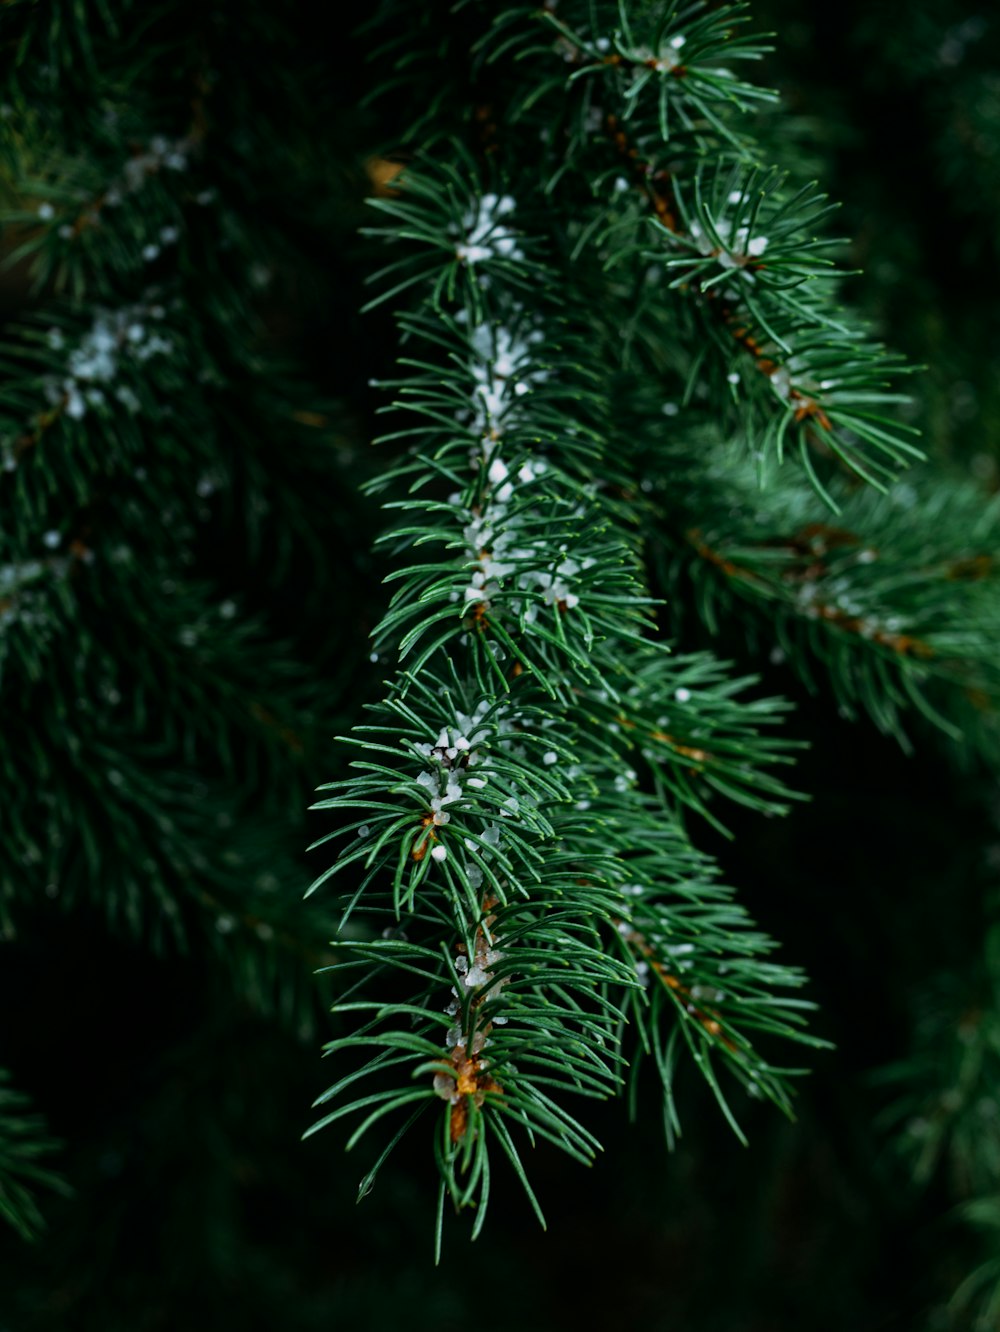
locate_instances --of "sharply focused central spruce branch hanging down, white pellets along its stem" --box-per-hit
[308,155,814,1232]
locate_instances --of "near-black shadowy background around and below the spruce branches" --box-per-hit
[0,0,1000,1332]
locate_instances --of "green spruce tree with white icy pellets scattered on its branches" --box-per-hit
[0,0,1000,1332]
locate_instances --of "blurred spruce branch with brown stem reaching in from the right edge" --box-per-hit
[652,434,1000,762]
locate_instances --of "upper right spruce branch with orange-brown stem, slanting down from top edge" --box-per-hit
[485,5,921,507]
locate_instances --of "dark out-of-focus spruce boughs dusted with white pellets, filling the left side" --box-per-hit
[0,4,366,1030]
